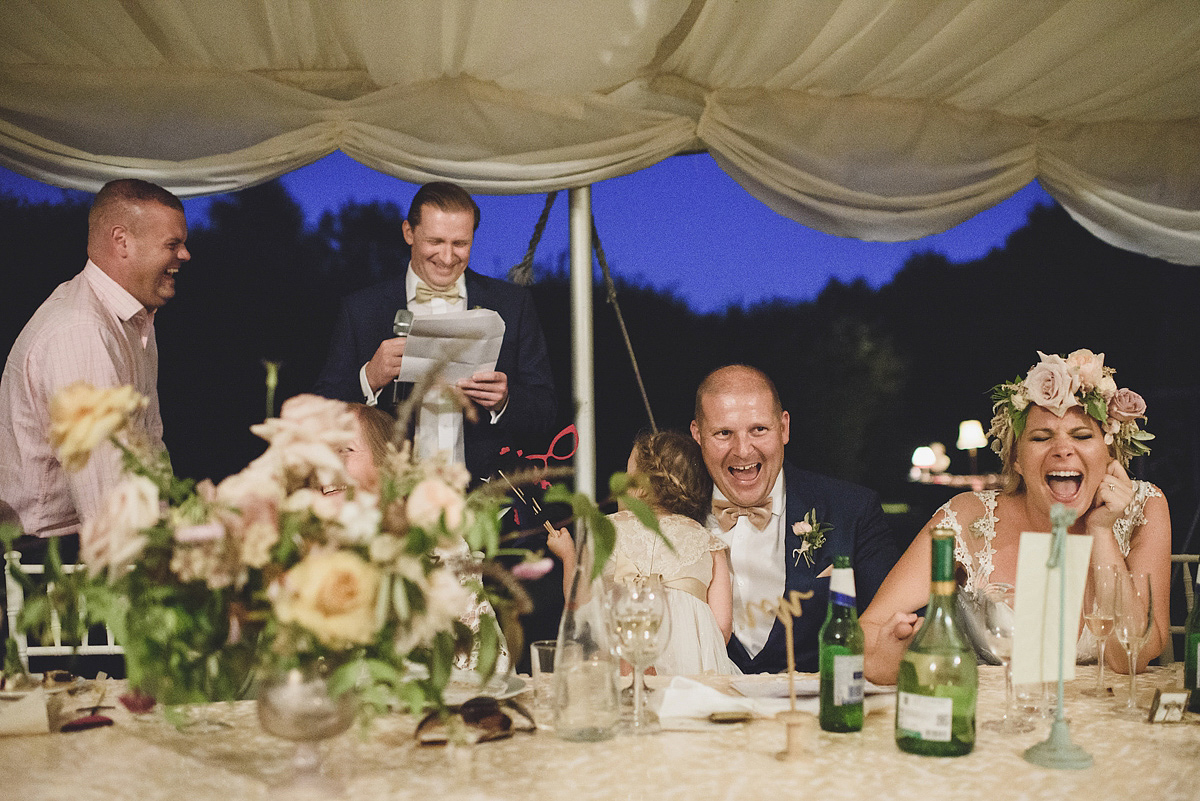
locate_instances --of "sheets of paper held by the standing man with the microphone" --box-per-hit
[398,308,504,384]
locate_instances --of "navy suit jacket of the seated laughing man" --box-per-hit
[727,462,900,673]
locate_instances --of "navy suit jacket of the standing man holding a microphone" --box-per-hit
[313,270,556,478]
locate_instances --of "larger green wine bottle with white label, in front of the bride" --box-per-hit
[895,528,979,757]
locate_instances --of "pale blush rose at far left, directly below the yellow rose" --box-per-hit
[79,476,162,578]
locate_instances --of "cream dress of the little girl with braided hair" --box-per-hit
[605,511,742,675]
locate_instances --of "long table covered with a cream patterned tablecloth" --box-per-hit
[0,664,1200,801]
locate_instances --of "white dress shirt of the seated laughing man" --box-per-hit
[709,469,787,657]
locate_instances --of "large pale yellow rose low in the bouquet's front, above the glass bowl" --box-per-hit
[275,550,380,648]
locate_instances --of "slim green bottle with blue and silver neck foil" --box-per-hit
[817,555,863,731]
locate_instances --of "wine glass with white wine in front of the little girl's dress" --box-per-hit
[608,576,671,734]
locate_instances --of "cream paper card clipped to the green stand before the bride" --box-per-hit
[1013,531,1092,685]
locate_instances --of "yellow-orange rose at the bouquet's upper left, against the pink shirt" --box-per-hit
[50,381,148,470]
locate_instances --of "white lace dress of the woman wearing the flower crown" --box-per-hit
[934,480,1163,663]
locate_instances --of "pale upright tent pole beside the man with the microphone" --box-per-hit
[569,186,596,499]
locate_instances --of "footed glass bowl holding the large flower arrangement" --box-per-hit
[257,660,358,797]
